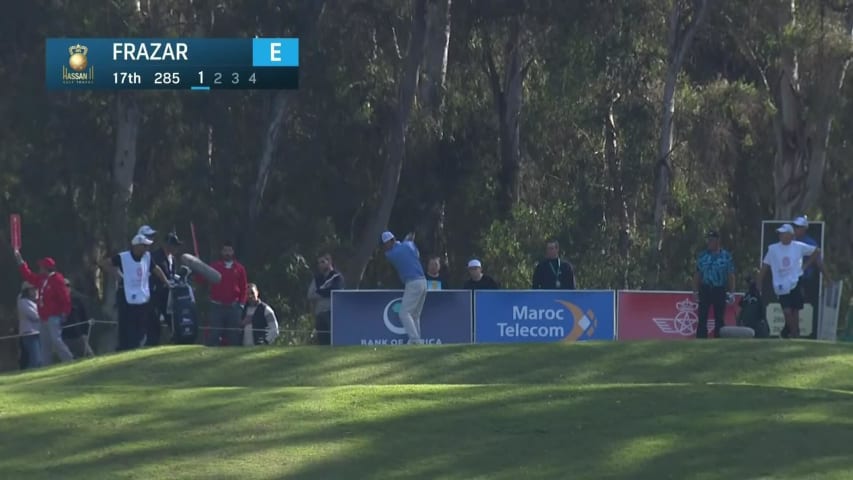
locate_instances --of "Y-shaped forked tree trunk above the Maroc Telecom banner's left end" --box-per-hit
[483,16,532,216]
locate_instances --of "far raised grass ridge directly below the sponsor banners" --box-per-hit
[5,341,853,390]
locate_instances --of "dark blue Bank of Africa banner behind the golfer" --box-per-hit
[332,290,474,345]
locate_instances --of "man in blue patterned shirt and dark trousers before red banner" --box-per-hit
[693,231,735,338]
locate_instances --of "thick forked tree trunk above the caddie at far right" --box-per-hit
[773,2,853,219]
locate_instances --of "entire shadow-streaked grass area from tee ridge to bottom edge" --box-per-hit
[0,341,853,480]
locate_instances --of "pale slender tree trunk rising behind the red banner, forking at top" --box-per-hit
[650,0,708,283]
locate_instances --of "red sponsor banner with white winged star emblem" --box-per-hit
[616,291,742,340]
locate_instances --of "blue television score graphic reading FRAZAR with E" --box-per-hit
[45,37,299,91]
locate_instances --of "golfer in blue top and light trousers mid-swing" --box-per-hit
[379,232,427,344]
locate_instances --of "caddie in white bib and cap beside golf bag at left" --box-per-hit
[101,234,169,351]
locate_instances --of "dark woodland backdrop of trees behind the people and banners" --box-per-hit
[0,0,853,368]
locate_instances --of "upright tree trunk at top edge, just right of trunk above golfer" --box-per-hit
[418,0,452,114]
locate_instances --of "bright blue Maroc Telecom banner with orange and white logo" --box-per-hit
[474,290,616,343]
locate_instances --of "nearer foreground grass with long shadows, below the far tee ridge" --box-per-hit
[0,385,853,480]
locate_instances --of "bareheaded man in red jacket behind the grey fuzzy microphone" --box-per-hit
[198,242,249,347]
